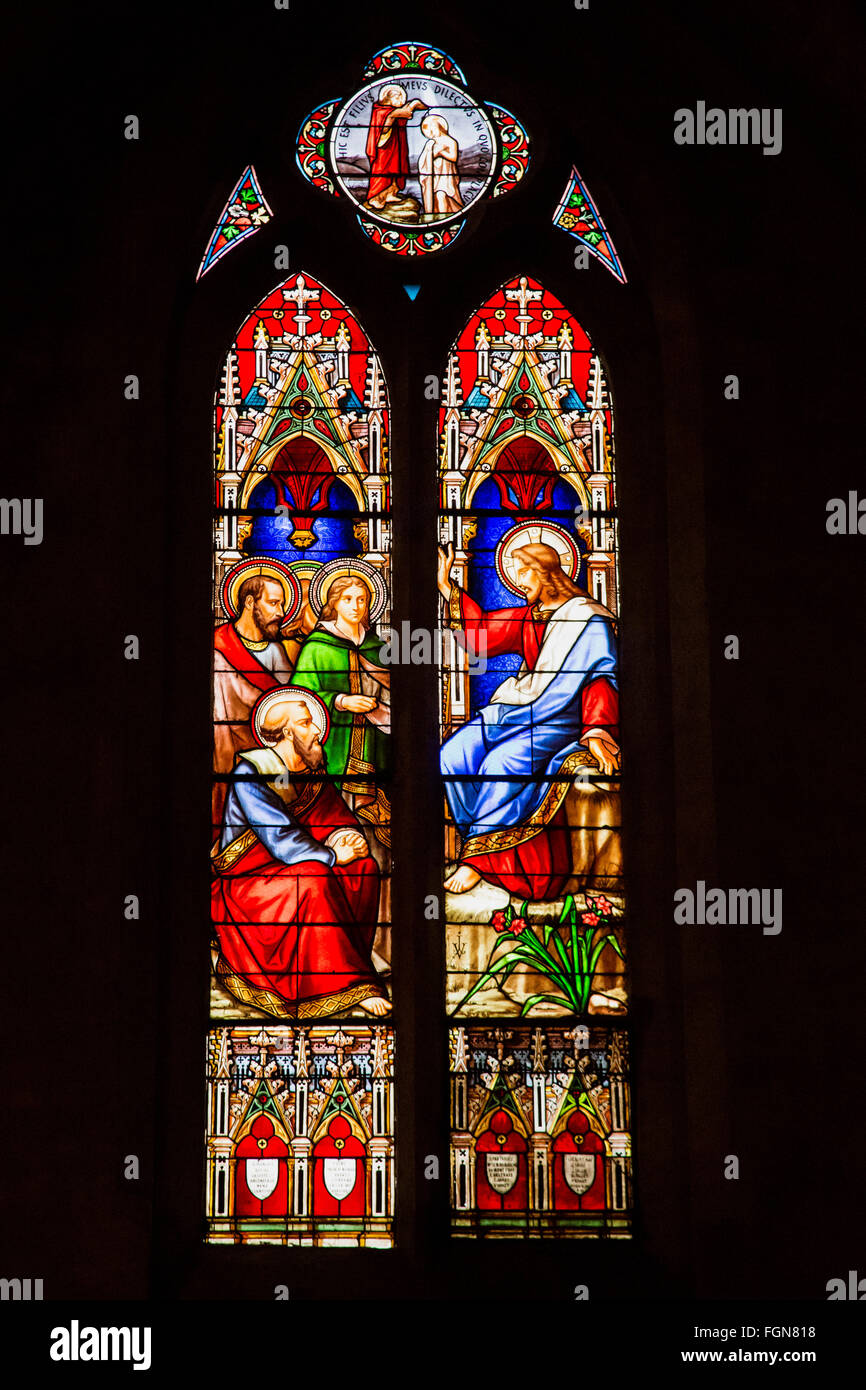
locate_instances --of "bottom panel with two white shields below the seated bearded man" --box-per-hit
[207,1024,393,1247]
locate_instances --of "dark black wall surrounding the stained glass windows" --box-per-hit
[0,0,866,1300]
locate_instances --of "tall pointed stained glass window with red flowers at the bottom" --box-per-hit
[438,275,631,1238]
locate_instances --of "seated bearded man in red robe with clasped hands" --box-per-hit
[211,687,391,1019]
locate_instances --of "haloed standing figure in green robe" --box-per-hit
[292,573,391,844]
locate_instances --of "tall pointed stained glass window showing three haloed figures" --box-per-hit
[206,274,395,1245]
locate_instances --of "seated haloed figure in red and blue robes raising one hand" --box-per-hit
[438,542,620,902]
